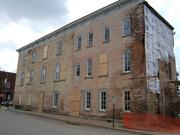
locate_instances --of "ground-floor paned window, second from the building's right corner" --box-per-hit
[99,91,107,111]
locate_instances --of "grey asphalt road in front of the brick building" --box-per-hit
[0,110,139,135]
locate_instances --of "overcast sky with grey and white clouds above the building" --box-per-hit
[0,0,180,72]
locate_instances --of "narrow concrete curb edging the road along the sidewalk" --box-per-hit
[11,109,158,135]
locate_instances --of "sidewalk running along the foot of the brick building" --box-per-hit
[10,108,175,135]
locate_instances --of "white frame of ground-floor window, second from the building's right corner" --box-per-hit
[99,90,107,112]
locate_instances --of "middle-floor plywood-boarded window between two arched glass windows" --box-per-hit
[99,53,108,76]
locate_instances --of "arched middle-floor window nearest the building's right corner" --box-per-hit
[123,49,131,72]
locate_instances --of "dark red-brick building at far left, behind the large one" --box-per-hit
[0,71,16,103]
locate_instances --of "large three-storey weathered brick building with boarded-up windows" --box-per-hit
[14,0,176,117]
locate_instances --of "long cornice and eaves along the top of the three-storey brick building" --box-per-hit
[17,0,174,52]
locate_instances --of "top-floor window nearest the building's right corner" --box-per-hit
[123,18,131,36]
